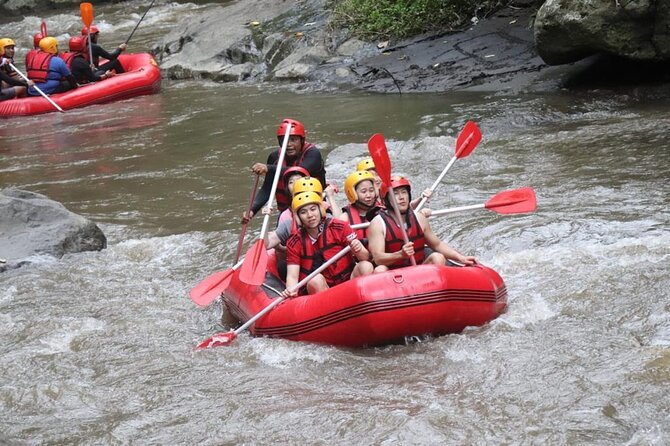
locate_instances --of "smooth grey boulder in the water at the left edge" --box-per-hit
[0,188,107,269]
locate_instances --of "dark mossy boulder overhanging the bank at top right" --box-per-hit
[534,0,670,65]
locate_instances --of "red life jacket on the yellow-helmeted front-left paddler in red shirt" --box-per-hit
[298,218,355,286]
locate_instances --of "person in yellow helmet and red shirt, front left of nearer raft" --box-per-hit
[282,192,373,297]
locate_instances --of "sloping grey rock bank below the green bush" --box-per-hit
[155,0,584,93]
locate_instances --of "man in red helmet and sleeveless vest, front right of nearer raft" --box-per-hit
[367,176,477,271]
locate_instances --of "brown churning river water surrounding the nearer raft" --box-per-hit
[0,3,670,445]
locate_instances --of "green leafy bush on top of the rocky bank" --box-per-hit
[329,0,509,40]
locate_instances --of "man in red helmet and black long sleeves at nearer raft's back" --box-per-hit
[241,118,326,224]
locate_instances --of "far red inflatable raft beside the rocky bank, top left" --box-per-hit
[0,53,161,117]
